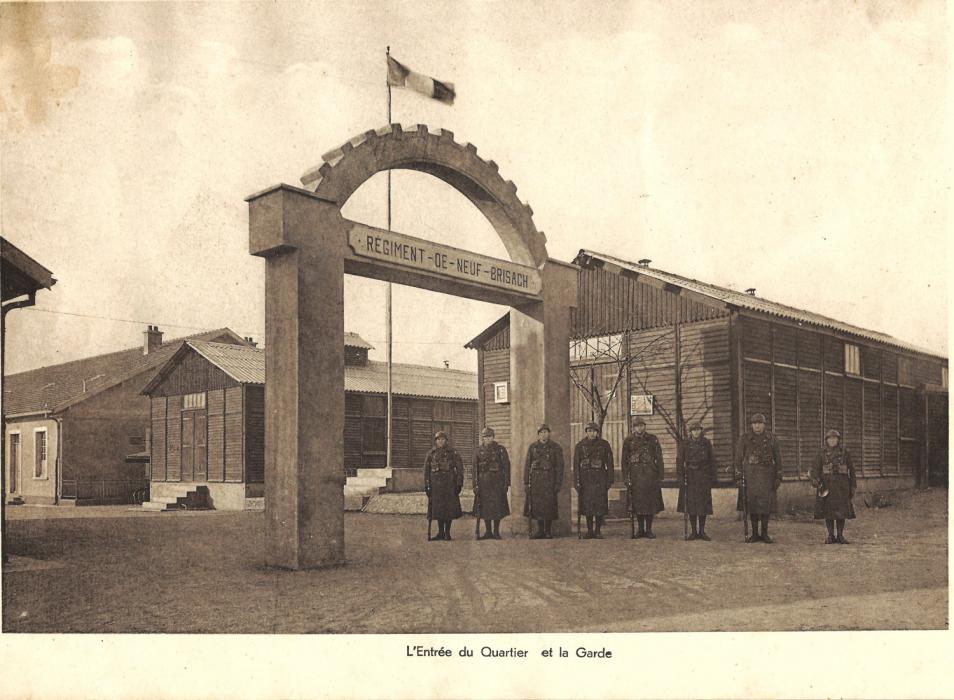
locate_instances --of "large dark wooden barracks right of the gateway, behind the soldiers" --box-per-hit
[466,250,948,507]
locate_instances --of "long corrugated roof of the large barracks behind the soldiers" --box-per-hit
[574,249,947,359]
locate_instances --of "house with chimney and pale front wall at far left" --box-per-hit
[3,326,250,505]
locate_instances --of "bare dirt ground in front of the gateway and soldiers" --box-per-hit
[3,490,948,633]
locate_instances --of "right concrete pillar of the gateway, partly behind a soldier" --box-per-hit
[504,260,577,536]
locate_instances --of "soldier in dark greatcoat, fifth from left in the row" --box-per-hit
[622,418,665,540]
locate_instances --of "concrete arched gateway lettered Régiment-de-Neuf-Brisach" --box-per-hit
[246,124,576,569]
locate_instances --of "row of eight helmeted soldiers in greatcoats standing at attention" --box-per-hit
[424,413,856,544]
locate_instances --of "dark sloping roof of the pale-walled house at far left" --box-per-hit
[3,328,245,418]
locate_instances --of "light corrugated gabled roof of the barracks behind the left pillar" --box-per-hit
[142,340,477,401]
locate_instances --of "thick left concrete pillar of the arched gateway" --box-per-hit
[248,185,346,569]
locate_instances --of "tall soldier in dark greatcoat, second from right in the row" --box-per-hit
[735,413,782,544]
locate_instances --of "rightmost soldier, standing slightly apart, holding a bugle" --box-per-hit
[809,430,857,544]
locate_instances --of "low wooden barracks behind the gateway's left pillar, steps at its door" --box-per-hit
[142,333,477,510]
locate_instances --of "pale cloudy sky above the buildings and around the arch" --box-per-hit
[0,1,950,373]
